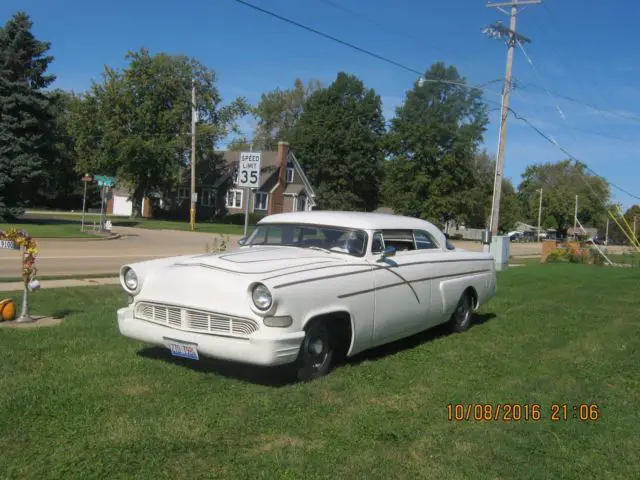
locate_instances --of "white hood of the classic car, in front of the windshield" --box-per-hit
[165,246,348,276]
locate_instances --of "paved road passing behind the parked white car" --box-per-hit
[0,227,632,277]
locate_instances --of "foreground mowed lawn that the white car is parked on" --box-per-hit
[0,264,640,480]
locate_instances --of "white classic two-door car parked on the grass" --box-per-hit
[117,211,496,381]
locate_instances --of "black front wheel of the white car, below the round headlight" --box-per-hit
[295,320,336,382]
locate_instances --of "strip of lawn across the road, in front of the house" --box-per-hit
[15,213,244,238]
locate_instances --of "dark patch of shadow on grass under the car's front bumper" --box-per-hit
[138,347,295,387]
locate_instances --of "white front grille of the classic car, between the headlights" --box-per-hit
[134,302,258,337]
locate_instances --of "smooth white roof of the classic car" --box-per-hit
[258,210,436,230]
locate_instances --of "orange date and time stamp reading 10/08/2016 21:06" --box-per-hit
[447,403,600,422]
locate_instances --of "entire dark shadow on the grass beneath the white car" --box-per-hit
[138,313,496,388]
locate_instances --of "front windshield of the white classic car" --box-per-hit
[245,223,367,257]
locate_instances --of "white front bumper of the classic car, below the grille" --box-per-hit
[118,307,305,366]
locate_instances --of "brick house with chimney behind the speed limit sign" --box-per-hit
[166,142,315,219]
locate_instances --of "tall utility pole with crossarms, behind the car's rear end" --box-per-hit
[483,0,542,235]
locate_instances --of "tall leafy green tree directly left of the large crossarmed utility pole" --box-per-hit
[382,63,488,225]
